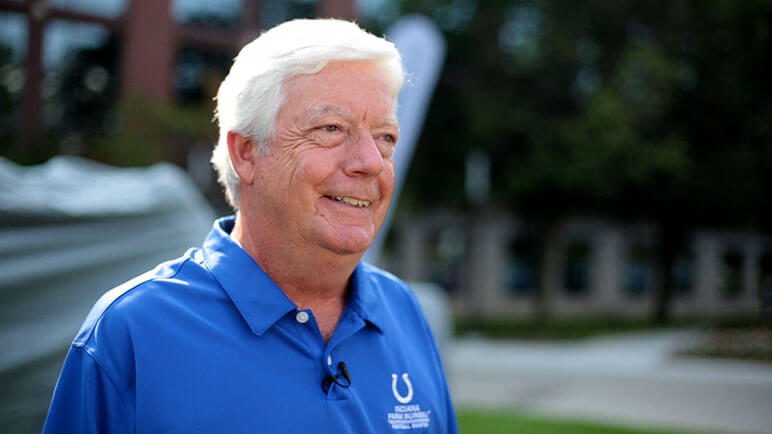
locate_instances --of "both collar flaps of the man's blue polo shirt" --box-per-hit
[203,216,384,336]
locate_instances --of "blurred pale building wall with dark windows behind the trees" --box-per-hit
[392,213,772,318]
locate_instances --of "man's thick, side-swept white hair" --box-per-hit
[212,19,404,210]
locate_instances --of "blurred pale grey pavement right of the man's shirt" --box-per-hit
[447,330,772,433]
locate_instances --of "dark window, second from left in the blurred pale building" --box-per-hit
[505,237,540,296]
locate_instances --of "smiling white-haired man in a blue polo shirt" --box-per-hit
[44,20,457,433]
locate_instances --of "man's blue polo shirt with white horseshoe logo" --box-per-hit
[44,217,457,434]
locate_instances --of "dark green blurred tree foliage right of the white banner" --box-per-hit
[368,0,772,229]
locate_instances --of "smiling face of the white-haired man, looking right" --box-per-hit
[247,61,399,254]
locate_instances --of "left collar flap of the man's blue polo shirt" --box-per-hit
[203,216,297,336]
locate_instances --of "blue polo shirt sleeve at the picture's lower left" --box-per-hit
[43,346,135,434]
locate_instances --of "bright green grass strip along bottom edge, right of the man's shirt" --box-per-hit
[457,409,704,434]
